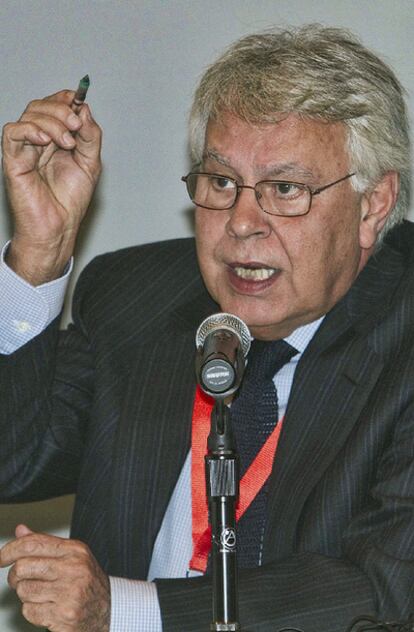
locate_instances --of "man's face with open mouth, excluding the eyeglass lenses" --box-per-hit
[196,114,370,339]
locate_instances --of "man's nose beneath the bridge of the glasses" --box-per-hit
[226,185,271,239]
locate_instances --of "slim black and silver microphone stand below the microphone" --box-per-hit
[205,399,241,632]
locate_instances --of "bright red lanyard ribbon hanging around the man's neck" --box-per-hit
[190,386,283,573]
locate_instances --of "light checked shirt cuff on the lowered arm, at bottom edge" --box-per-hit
[109,577,162,632]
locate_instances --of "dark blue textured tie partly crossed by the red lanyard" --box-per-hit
[231,340,298,568]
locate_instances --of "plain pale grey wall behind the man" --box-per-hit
[0,0,414,632]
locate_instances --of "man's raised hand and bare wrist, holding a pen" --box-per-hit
[2,90,101,285]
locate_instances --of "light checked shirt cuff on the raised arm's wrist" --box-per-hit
[0,244,73,354]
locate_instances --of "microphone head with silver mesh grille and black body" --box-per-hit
[196,312,251,399]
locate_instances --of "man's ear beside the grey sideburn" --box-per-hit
[359,171,400,249]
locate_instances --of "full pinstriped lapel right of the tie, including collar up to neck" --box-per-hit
[264,236,403,560]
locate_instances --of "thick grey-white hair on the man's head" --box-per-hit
[190,24,410,234]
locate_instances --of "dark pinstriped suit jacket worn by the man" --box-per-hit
[0,223,414,632]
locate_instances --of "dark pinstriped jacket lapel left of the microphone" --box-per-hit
[111,291,218,579]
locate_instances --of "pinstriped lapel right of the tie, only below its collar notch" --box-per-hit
[267,326,383,557]
